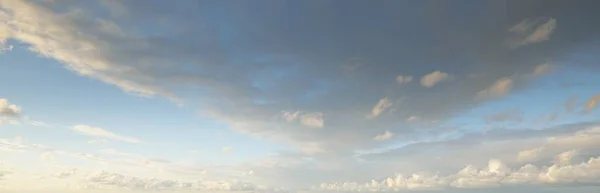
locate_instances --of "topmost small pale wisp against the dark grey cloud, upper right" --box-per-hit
[508,18,556,48]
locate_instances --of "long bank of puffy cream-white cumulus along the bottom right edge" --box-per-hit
[317,154,600,192]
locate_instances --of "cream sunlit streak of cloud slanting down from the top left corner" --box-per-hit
[0,1,178,101]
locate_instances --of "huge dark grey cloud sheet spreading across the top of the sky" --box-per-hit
[0,0,600,155]
